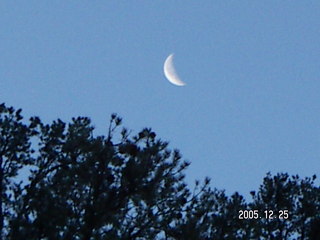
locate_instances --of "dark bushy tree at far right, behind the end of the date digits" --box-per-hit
[250,173,320,239]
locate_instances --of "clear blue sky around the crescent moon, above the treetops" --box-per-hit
[0,0,320,198]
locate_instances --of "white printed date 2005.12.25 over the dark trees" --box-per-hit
[238,210,289,220]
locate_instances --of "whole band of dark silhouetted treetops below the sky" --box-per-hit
[0,104,320,240]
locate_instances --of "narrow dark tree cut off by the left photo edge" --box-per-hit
[0,104,36,239]
